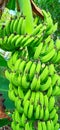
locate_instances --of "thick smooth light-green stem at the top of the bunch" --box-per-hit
[18,0,33,34]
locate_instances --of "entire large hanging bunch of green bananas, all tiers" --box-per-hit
[0,10,60,130]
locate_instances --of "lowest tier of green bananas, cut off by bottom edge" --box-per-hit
[11,110,59,130]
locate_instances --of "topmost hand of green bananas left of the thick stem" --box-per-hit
[1,16,25,37]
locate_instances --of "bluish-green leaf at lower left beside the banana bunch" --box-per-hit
[0,75,14,111]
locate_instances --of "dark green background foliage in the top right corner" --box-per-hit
[34,0,60,37]
